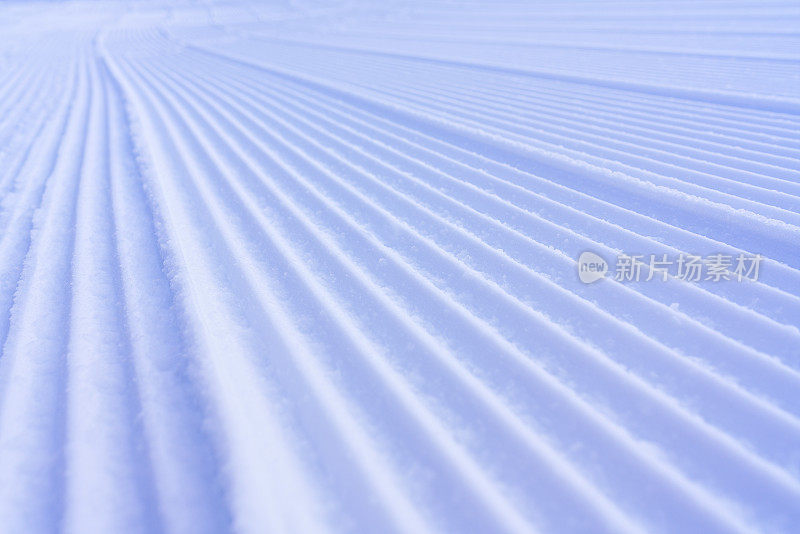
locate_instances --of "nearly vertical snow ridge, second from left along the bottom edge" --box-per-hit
[63,52,160,532]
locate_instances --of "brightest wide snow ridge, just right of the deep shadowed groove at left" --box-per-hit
[104,55,342,530]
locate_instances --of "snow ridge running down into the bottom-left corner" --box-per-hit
[0,49,91,530]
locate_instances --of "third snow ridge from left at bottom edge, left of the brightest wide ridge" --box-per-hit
[97,53,230,532]
